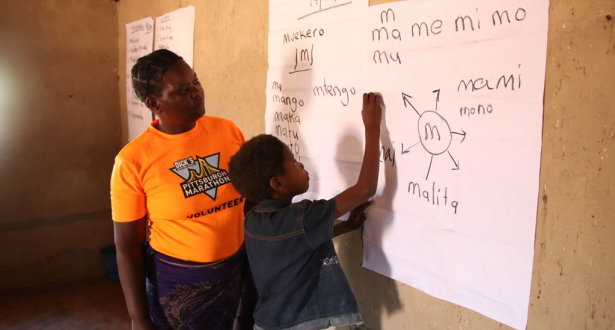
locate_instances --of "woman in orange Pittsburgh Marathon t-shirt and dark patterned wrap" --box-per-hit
[111,49,258,330]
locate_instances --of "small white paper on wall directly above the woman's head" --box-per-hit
[154,6,194,67]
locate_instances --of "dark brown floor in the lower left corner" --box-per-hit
[0,277,130,330]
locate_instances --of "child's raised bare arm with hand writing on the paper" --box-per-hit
[333,93,382,217]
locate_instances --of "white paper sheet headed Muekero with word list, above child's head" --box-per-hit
[265,0,368,198]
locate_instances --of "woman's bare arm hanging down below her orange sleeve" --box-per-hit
[113,216,155,330]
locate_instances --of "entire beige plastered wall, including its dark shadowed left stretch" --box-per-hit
[0,0,600,330]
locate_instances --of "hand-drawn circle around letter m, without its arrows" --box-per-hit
[418,111,453,155]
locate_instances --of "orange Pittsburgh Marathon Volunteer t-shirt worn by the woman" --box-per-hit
[111,116,244,262]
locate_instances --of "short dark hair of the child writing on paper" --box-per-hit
[228,134,284,202]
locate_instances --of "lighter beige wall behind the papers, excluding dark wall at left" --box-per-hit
[118,0,615,330]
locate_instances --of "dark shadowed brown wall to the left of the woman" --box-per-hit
[0,0,121,289]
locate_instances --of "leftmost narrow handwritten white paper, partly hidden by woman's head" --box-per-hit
[126,17,154,140]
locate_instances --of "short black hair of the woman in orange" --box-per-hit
[130,49,182,102]
